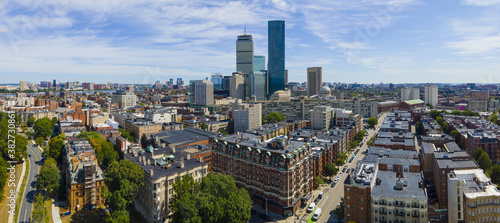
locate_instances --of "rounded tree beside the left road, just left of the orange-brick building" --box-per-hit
[37,157,61,196]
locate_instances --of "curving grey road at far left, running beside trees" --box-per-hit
[17,140,43,223]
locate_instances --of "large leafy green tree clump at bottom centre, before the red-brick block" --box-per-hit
[172,174,252,223]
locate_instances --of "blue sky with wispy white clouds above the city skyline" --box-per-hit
[0,0,500,84]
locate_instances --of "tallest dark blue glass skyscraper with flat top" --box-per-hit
[267,20,285,95]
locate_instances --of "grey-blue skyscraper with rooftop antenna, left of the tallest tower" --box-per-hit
[236,34,254,74]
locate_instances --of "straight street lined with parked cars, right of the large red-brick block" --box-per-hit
[314,113,387,223]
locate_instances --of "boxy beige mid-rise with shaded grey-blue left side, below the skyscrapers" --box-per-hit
[231,101,262,132]
